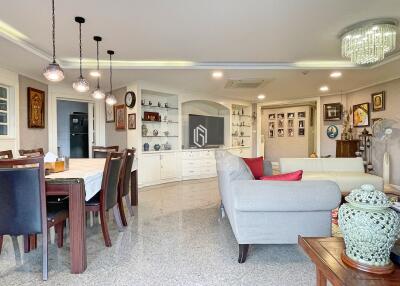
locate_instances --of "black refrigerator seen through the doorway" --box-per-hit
[69,112,89,158]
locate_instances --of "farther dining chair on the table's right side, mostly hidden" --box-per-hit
[118,149,136,226]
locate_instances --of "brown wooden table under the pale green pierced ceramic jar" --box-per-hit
[298,235,400,286]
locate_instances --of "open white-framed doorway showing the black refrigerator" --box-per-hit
[57,99,93,158]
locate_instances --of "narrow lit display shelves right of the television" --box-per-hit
[231,104,252,147]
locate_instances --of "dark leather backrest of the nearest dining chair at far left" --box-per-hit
[0,156,47,235]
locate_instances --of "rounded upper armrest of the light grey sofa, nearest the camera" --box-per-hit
[232,180,341,212]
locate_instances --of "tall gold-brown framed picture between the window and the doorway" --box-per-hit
[28,87,45,128]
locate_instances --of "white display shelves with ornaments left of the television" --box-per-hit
[141,89,180,152]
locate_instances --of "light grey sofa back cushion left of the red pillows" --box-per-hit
[215,150,254,182]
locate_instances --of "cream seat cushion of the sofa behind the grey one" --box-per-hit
[303,172,383,192]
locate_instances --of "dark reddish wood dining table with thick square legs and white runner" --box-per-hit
[24,158,138,274]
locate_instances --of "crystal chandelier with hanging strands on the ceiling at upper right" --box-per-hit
[340,19,397,65]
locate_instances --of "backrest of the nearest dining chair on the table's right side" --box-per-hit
[100,152,124,210]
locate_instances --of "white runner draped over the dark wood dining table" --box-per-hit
[46,158,137,201]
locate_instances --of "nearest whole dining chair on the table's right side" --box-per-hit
[85,152,125,247]
